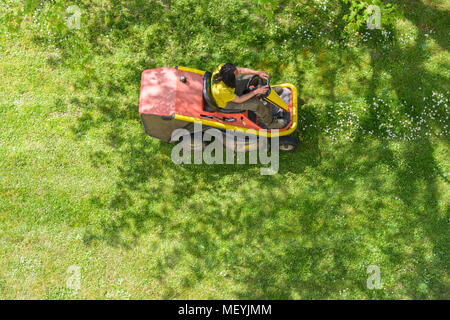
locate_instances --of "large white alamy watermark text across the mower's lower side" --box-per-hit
[171,122,280,175]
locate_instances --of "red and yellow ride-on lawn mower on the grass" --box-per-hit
[139,67,298,151]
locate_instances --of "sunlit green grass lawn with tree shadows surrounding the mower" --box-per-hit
[0,0,450,299]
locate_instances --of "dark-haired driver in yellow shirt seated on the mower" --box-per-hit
[211,63,286,129]
